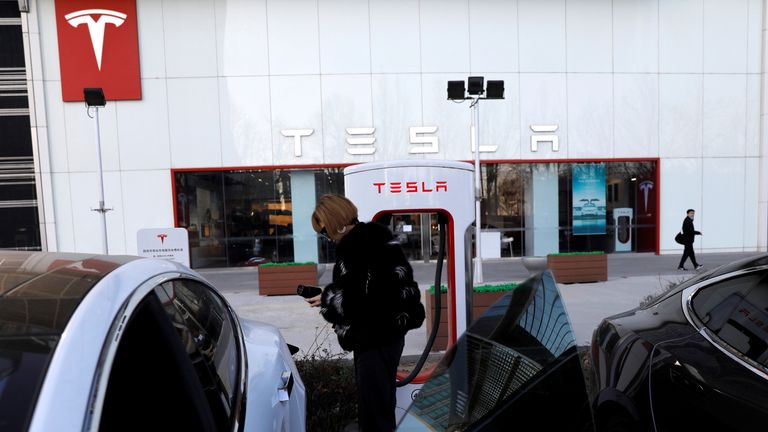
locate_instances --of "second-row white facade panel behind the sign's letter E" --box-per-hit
[322,74,381,163]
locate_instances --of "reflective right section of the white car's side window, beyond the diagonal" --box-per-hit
[155,279,239,428]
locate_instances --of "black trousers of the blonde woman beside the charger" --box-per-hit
[354,337,405,432]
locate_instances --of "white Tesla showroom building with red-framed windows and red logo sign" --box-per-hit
[0,0,768,268]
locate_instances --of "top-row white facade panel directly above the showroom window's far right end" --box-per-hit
[613,0,659,73]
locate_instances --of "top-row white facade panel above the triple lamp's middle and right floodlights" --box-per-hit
[469,0,519,73]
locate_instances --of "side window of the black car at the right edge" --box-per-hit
[691,271,768,366]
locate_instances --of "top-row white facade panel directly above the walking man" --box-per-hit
[659,0,704,73]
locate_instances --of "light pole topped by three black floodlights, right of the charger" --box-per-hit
[448,76,504,283]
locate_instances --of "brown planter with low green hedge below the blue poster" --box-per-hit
[547,252,608,283]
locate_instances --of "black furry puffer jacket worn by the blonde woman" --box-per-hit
[320,222,424,351]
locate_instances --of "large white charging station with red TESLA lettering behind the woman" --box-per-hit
[344,160,475,418]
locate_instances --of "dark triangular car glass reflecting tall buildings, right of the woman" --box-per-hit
[398,271,591,431]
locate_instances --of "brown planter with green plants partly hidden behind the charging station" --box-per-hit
[425,283,517,351]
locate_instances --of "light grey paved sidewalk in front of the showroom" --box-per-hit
[199,252,759,354]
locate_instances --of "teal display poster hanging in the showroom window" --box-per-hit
[572,163,606,235]
